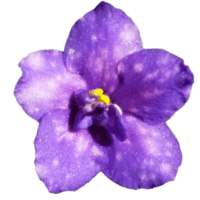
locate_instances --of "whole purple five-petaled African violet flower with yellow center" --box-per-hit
[14,1,194,193]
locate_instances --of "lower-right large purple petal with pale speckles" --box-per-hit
[102,116,182,190]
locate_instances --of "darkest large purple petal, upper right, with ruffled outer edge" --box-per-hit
[111,49,194,124]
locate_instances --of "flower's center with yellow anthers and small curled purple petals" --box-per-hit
[73,88,126,141]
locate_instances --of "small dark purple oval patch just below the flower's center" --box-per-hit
[88,125,113,146]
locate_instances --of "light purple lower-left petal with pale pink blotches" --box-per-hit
[34,110,108,193]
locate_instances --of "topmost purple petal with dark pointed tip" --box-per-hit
[64,1,143,93]
